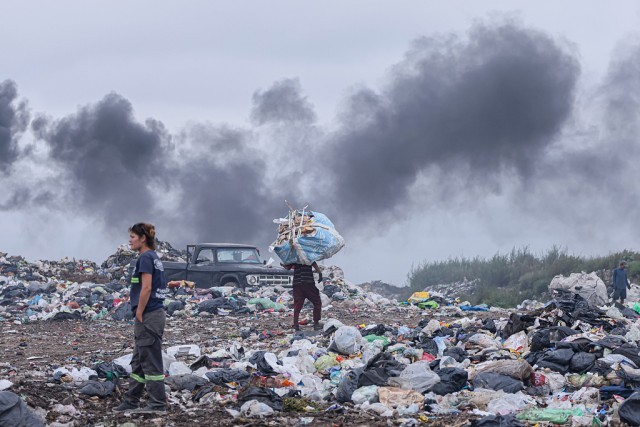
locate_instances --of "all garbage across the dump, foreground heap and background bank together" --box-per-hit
[6,247,640,426]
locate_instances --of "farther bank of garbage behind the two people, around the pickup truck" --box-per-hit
[0,242,396,323]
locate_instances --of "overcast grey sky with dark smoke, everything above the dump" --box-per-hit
[0,0,640,285]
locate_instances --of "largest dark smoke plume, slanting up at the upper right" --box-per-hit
[327,23,579,224]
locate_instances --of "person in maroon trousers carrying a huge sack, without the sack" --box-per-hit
[281,262,322,331]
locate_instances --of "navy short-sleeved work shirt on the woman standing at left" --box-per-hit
[130,251,167,313]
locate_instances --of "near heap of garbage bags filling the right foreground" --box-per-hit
[10,269,640,426]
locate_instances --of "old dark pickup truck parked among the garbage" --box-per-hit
[162,243,293,288]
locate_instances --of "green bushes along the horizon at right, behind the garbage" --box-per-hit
[407,246,640,307]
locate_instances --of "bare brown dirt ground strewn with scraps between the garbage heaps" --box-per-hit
[0,301,484,427]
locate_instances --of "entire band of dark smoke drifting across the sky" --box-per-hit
[6,21,640,256]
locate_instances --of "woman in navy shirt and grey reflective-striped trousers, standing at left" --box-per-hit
[114,223,167,413]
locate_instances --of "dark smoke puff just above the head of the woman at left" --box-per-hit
[32,94,170,230]
